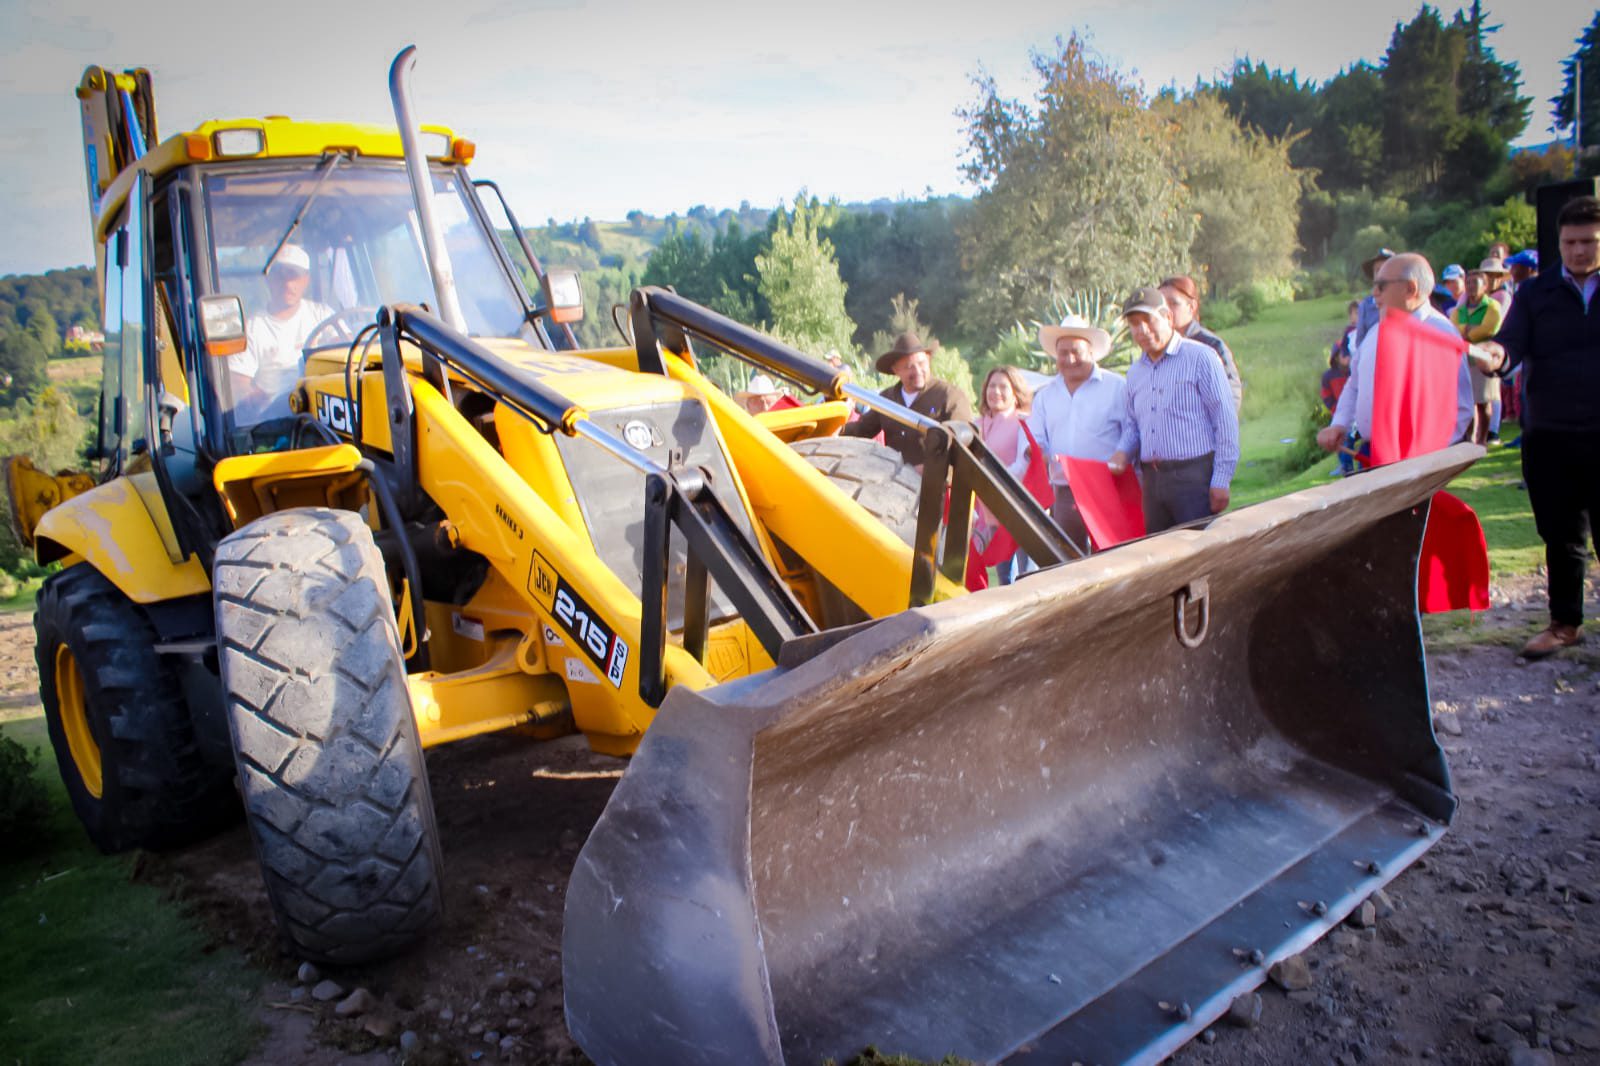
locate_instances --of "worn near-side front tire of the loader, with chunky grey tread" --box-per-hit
[213,507,443,965]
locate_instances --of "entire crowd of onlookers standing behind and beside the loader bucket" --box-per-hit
[741,189,1600,658]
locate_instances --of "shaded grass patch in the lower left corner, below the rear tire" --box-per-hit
[0,714,261,1066]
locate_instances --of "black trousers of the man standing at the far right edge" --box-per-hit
[1522,429,1600,626]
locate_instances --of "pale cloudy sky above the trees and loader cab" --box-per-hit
[0,0,1595,275]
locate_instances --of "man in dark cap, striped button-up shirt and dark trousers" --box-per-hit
[1109,287,1238,533]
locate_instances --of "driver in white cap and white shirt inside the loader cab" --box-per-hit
[227,245,333,423]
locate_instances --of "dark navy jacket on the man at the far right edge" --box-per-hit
[1494,269,1600,434]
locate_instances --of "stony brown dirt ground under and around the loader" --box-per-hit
[0,581,1600,1066]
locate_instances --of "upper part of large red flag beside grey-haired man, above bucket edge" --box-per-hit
[1371,302,1467,466]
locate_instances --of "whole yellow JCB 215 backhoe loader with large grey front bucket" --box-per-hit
[8,50,1478,1064]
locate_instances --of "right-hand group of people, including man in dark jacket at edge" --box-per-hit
[1317,197,1600,658]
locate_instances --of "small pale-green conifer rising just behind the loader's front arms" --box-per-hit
[755,190,856,364]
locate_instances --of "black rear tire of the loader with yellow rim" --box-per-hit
[34,563,238,853]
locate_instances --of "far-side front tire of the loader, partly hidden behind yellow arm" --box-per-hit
[790,437,922,629]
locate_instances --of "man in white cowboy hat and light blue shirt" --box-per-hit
[1027,308,1128,546]
